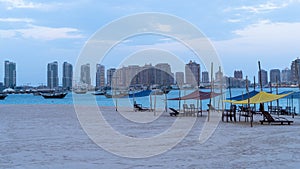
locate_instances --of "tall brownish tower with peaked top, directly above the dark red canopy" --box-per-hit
[185,61,200,86]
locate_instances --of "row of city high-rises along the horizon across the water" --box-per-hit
[0,58,300,89]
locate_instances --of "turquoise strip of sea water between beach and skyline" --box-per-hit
[0,88,300,113]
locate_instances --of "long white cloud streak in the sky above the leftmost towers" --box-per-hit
[0,25,84,40]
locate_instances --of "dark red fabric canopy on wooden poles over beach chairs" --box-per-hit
[168,90,222,100]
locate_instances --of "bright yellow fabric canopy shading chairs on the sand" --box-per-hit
[232,91,293,104]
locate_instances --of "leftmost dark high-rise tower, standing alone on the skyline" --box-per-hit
[4,61,16,88]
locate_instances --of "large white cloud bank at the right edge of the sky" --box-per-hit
[215,20,300,55]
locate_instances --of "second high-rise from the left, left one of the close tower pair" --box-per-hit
[47,61,58,89]
